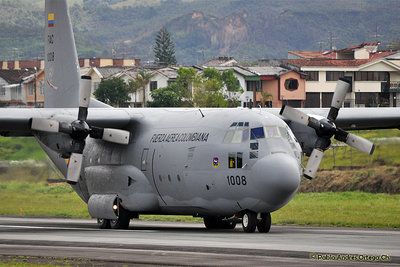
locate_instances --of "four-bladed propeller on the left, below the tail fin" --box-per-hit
[31,76,130,184]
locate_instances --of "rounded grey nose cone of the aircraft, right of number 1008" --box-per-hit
[251,153,301,210]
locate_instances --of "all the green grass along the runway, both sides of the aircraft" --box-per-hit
[0,182,400,229]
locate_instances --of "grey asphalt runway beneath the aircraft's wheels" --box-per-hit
[0,217,400,266]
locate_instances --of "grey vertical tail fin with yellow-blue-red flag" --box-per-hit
[44,0,80,108]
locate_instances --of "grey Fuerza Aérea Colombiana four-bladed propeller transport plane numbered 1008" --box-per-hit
[0,0,400,232]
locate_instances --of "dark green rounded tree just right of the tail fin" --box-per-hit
[94,77,129,107]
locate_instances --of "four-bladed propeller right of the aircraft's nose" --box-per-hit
[279,79,375,179]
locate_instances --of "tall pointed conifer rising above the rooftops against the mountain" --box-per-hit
[153,27,176,66]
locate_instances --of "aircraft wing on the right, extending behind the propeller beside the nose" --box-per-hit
[270,108,400,130]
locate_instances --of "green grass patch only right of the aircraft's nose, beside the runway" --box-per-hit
[272,192,400,228]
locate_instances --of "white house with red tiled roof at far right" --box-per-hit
[284,42,400,107]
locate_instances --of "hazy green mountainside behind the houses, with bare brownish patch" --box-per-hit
[0,0,400,64]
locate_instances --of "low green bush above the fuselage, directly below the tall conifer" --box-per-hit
[148,83,182,107]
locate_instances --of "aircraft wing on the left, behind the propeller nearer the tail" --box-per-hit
[0,108,133,136]
